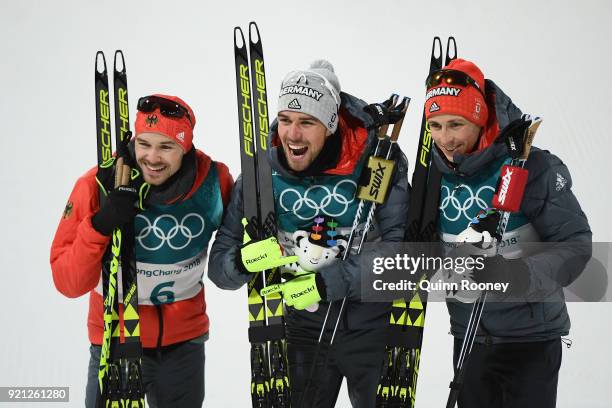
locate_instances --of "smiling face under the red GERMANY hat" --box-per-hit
[428,115,482,162]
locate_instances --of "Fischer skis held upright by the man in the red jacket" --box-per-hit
[95,50,145,408]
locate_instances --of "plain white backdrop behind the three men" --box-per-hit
[0,0,612,407]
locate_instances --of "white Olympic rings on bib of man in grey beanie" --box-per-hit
[279,180,357,221]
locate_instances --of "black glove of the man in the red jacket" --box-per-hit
[91,186,138,236]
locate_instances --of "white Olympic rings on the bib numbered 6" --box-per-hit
[136,213,206,251]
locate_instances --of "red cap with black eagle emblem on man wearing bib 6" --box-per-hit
[134,94,196,152]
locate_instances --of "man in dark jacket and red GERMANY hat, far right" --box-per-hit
[425,59,592,408]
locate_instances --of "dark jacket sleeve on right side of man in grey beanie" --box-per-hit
[319,149,410,301]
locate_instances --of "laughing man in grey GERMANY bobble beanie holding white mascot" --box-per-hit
[209,61,409,407]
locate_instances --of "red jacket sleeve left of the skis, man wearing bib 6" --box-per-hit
[50,169,110,298]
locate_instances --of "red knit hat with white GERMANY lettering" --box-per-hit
[425,58,489,127]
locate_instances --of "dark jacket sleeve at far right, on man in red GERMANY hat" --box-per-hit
[521,150,592,295]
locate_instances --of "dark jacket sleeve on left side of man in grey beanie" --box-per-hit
[208,176,253,290]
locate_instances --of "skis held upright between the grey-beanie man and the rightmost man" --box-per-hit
[376,37,457,408]
